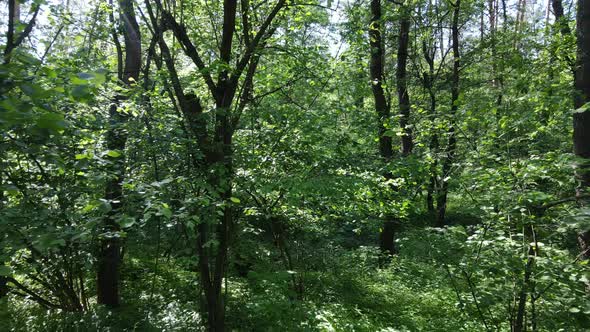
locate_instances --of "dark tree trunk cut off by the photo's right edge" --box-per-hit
[573,0,590,259]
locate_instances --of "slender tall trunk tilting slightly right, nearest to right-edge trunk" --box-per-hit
[436,0,461,226]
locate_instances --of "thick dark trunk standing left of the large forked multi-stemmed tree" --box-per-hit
[96,0,141,307]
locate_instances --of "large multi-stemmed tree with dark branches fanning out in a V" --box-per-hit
[146,0,287,331]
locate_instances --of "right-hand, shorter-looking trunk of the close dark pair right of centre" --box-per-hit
[396,6,414,157]
